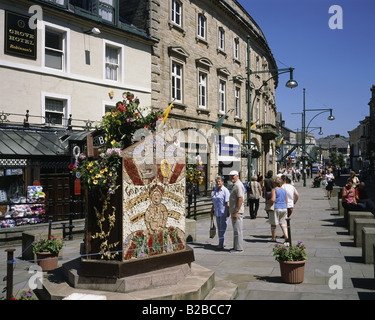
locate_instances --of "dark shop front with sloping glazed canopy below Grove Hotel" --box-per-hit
[0,128,87,228]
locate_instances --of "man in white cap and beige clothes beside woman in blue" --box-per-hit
[229,170,245,252]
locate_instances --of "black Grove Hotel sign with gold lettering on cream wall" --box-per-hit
[4,11,37,60]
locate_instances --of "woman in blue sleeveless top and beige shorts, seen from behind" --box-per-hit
[266,177,289,242]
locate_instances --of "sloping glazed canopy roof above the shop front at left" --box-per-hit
[0,129,88,157]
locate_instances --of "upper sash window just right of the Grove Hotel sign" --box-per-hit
[44,28,66,70]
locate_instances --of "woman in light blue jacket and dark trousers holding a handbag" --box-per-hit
[211,176,229,250]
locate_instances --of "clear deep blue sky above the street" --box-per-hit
[238,0,375,138]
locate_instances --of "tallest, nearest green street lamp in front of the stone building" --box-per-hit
[246,35,298,182]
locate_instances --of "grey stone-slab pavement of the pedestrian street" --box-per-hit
[0,175,375,300]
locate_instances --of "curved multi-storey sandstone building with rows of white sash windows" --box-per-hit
[121,0,278,188]
